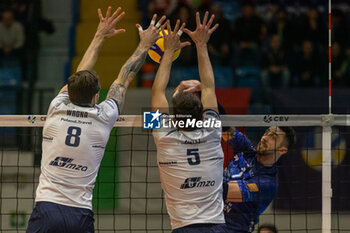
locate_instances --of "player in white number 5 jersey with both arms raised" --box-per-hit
[152,12,226,233]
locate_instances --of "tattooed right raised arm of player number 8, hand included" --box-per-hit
[107,15,166,111]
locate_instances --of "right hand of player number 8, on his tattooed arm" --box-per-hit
[136,14,166,50]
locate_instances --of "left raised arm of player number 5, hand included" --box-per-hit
[152,20,190,113]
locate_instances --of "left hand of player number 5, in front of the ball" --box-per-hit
[162,20,191,52]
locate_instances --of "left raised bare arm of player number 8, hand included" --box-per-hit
[60,6,125,93]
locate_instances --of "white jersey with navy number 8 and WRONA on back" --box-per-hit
[35,92,119,209]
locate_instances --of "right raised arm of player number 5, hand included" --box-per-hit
[184,12,219,111]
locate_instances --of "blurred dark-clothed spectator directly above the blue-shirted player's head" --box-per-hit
[261,34,290,94]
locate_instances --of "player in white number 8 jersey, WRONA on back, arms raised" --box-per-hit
[27,7,165,233]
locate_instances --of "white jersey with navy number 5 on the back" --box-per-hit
[153,110,225,229]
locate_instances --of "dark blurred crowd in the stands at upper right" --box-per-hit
[143,0,350,93]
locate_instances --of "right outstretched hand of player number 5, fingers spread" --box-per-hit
[184,11,219,45]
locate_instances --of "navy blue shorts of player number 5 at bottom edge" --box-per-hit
[172,223,227,233]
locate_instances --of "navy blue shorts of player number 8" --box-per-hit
[26,202,95,233]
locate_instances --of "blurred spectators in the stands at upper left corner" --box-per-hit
[0,0,55,85]
